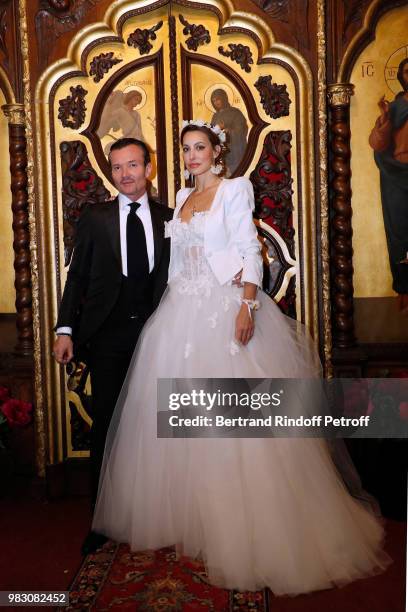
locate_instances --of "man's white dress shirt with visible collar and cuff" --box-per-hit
[56,192,154,336]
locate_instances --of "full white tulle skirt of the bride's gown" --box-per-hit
[93,283,389,595]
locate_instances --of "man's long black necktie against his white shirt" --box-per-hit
[126,202,149,280]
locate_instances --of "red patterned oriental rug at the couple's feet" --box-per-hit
[60,542,269,612]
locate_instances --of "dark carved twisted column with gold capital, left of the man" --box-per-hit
[2,104,33,355]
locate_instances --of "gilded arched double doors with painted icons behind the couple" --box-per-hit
[35,0,319,459]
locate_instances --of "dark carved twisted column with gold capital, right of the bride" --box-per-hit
[328,83,356,348]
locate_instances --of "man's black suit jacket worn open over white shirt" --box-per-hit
[56,198,173,349]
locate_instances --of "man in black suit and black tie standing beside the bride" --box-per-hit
[54,138,172,552]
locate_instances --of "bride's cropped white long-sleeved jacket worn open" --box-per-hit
[169,176,262,287]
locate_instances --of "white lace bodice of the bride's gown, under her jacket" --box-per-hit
[165,212,215,295]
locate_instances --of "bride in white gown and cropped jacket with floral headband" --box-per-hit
[93,121,389,595]
